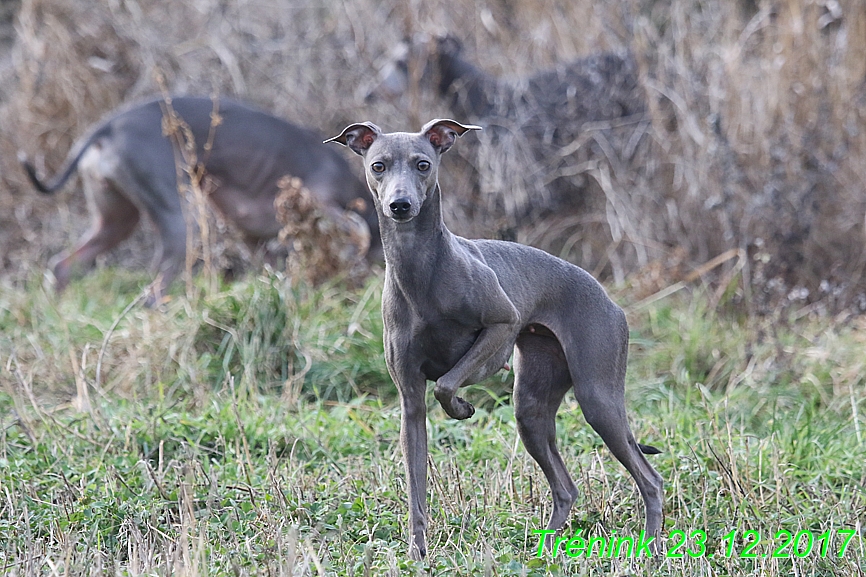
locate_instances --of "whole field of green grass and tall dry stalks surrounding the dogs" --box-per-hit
[0,0,866,577]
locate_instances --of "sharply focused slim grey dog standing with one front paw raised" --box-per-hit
[326,120,663,558]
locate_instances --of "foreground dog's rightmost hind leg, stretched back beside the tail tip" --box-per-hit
[568,318,664,537]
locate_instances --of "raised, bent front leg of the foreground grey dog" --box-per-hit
[433,323,516,419]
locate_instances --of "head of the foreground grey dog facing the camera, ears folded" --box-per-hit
[325,119,480,223]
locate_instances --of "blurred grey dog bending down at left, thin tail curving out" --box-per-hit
[24,97,379,292]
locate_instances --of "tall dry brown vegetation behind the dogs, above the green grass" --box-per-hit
[0,0,866,312]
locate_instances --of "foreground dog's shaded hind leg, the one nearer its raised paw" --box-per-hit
[514,326,577,543]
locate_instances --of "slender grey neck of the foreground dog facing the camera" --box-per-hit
[379,183,454,294]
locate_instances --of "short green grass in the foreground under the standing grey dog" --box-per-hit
[0,270,866,576]
